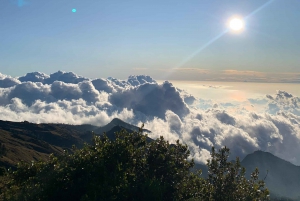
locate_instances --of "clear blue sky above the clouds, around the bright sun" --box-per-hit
[0,0,300,81]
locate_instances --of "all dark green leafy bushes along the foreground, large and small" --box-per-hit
[1,129,269,201]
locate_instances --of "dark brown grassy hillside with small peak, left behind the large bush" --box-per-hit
[0,119,146,167]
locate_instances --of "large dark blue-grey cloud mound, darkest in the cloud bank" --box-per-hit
[109,82,189,118]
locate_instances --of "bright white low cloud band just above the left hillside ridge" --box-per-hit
[0,98,134,126]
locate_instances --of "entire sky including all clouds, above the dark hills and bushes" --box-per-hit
[0,0,300,165]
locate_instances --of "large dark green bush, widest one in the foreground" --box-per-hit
[2,130,204,201]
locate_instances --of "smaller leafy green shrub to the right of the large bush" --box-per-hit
[206,147,269,201]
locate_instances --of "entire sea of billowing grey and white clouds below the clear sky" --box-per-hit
[0,71,300,165]
